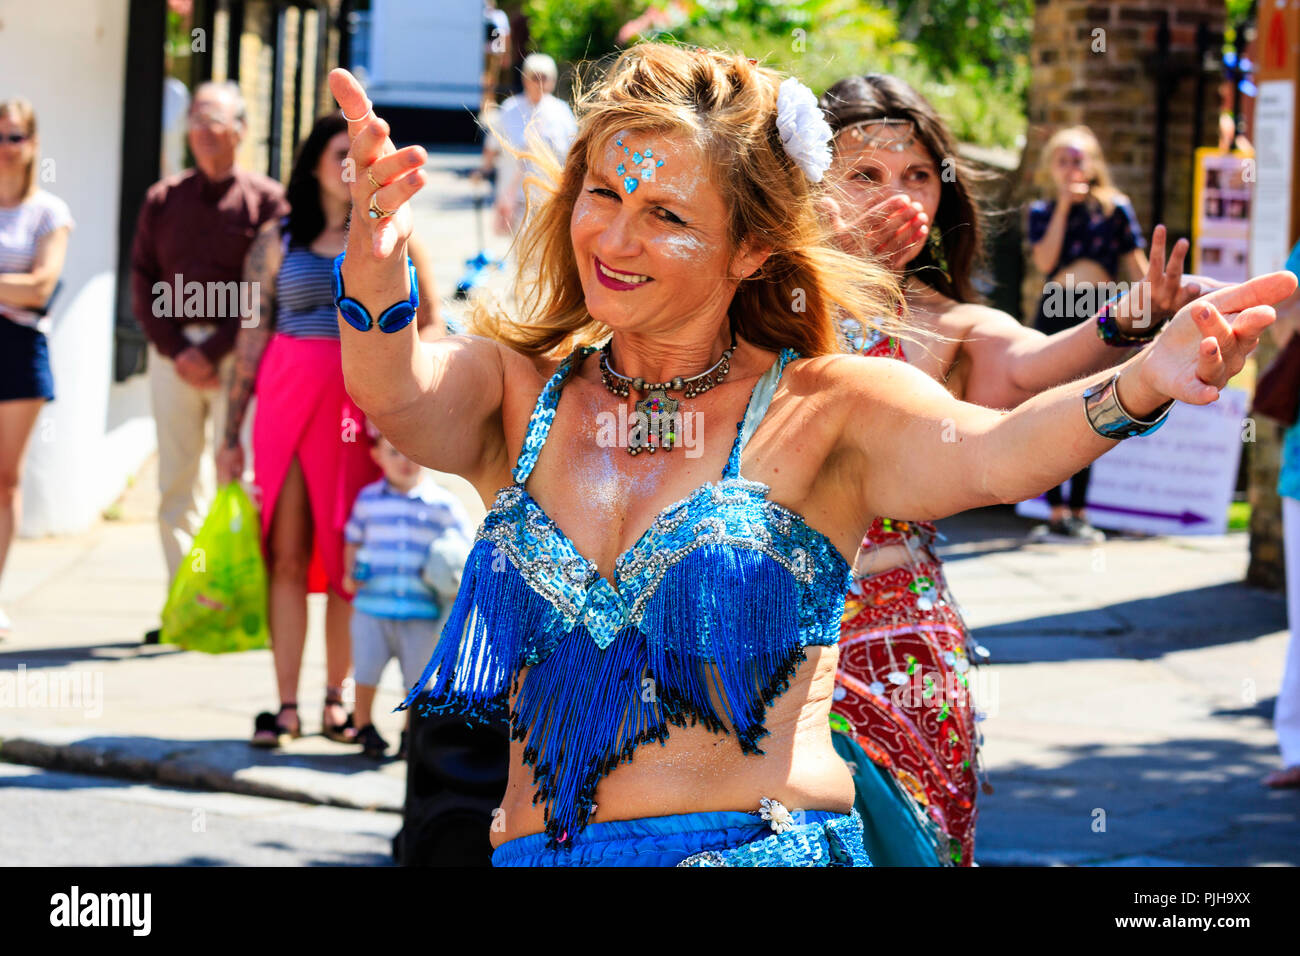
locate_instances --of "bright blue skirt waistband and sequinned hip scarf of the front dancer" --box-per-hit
[491,810,871,866]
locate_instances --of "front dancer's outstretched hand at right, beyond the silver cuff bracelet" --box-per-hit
[1123,272,1296,416]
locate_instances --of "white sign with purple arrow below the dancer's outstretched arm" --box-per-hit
[1015,388,1247,535]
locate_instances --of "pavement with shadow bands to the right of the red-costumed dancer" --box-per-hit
[941,509,1300,866]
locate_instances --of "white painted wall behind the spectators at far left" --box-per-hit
[0,0,155,536]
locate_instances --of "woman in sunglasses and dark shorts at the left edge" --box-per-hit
[0,99,73,639]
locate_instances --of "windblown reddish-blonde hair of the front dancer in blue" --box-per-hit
[468,43,906,356]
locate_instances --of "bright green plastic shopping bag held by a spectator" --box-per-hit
[160,481,270,654]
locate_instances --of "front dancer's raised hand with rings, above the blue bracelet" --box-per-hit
[329,69,426,264]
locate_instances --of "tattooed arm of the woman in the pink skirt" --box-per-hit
[217,220,282,484]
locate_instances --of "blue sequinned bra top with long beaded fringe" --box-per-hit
[400,346,853,848]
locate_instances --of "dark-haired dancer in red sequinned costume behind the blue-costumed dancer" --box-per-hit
[822,74,1199,865]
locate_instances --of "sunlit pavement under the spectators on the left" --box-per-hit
[0,459,484,812]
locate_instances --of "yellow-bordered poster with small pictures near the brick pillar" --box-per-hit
[1192,148,1255,282]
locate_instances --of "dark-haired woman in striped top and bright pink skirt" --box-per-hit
[217,112,445,747]
